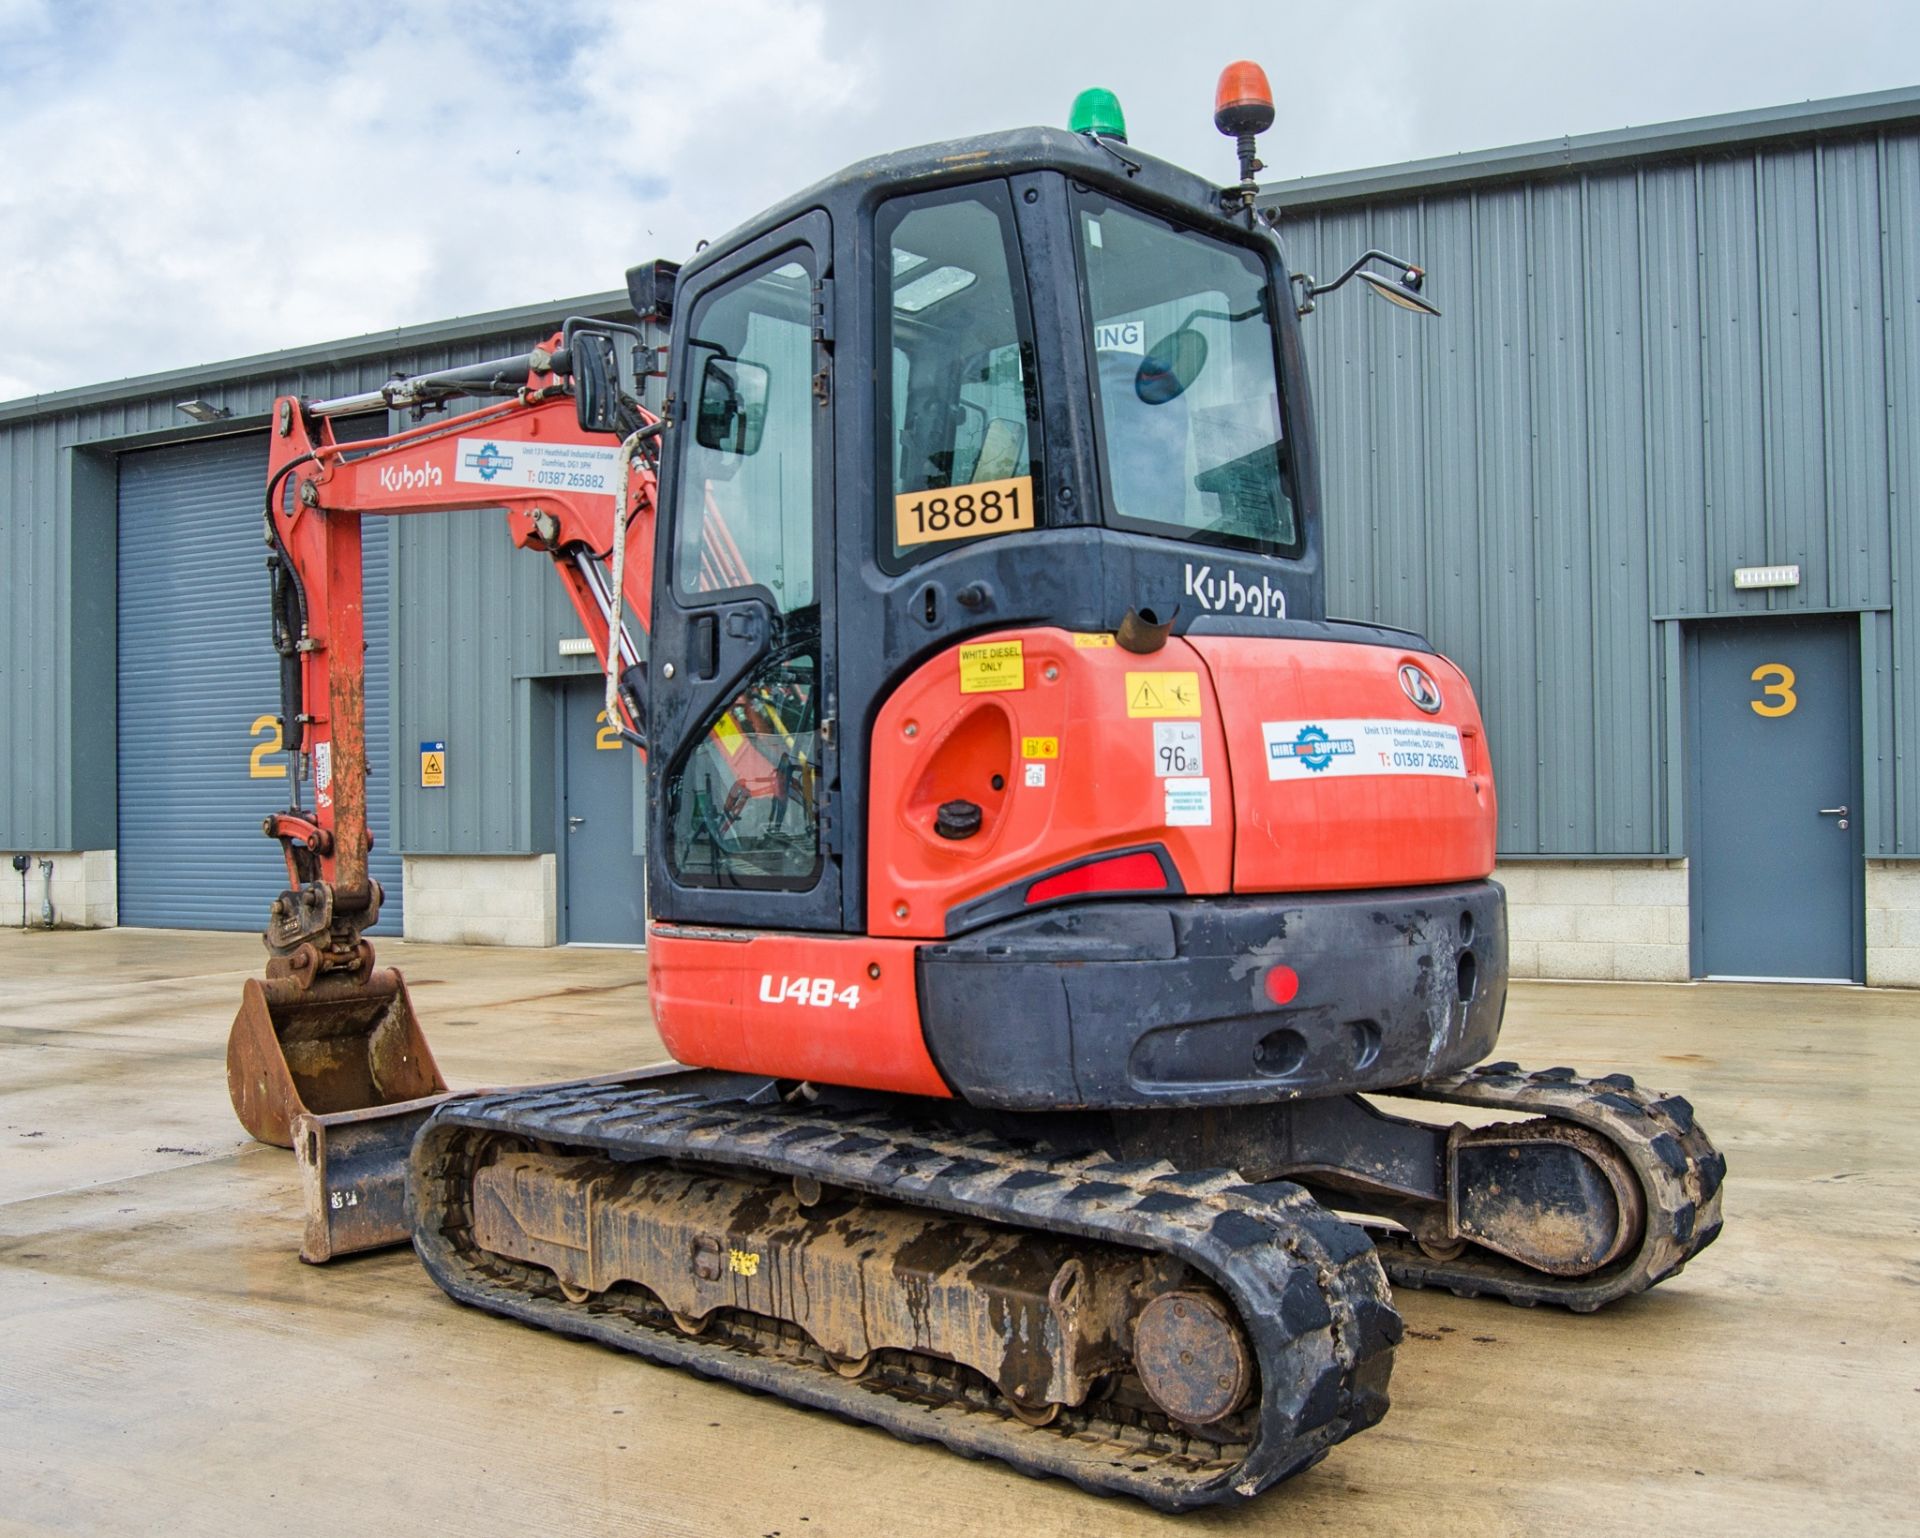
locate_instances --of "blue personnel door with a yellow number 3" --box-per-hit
[1690,614,1866,983]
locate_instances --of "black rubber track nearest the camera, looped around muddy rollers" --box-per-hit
[411,1069,1402,1511]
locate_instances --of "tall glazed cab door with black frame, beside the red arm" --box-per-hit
[647,211,841,929]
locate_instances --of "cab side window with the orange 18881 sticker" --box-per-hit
[876,182,1043,570]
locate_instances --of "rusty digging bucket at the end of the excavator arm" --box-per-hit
[227,968,447,1148]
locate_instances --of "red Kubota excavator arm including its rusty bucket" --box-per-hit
[228,321,662,1146]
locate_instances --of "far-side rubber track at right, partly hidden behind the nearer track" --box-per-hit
[1375,1062,1726,1313]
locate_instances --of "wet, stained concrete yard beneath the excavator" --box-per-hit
[0,931,1920,1538]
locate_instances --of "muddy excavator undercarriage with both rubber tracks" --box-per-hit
[411,1064,1724,1509]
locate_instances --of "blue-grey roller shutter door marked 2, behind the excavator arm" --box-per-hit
[119,434,399,935]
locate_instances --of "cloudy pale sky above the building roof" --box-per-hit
[0,0,1920,399]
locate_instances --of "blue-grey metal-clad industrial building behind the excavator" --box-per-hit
[0,90,1920,985]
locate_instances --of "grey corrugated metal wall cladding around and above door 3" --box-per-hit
[1271,122,1920,856]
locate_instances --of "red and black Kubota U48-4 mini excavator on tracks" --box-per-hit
[228,63,1724,1509]
